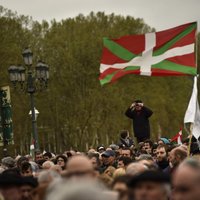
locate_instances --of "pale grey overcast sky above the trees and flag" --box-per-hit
[0,0,200,31]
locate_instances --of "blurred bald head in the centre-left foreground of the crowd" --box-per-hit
[66,155,94,177]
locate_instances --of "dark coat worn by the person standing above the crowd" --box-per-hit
[125,106,153,138]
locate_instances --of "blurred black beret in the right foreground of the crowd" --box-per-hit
[128,170,170,187]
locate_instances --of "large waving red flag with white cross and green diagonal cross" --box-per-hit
[99,22,197,85]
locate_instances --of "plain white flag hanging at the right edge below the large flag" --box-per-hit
[184,76,200,139]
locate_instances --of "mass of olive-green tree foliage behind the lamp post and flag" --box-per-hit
[0,7,199,153]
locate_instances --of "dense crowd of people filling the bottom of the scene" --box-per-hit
[0,130,200,200]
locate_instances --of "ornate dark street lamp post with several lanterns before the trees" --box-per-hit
[8,48,49,150]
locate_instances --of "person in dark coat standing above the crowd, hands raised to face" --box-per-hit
[125,100,153,143]
